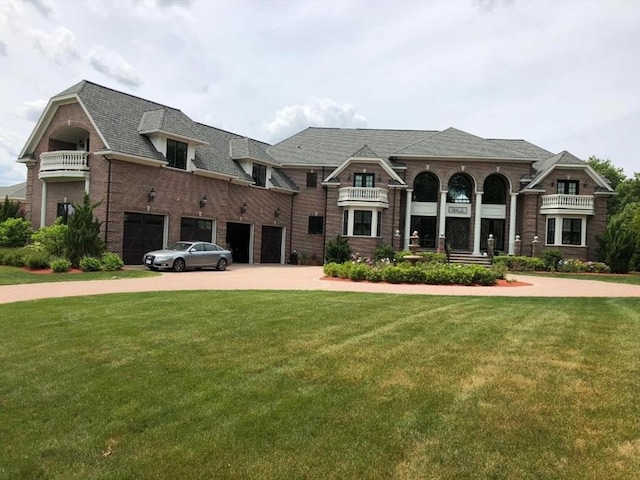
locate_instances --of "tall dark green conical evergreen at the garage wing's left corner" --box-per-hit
[65,194,105,267]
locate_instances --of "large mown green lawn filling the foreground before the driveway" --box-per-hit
[0,291,640,480]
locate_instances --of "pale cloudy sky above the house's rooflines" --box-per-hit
[0,0,640,186]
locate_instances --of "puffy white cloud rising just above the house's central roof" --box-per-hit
[266,97,367,141]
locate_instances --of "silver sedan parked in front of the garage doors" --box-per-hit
[142,242,233,272]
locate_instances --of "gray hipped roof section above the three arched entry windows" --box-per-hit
[396,128,531,160]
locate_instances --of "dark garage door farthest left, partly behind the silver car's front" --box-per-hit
[122,212,164,265]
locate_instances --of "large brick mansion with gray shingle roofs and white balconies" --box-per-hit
[18,81,613,264]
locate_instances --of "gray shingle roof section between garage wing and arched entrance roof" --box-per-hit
[267,127,437,167]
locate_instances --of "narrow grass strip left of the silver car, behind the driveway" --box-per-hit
[0,266,160,285]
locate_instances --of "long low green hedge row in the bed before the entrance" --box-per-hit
[324,262,503,285]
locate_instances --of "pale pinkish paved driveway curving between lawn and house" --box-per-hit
[0,265,640,304]
